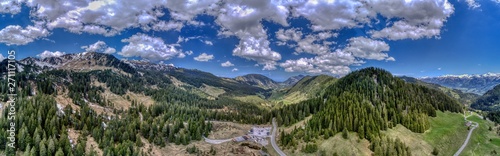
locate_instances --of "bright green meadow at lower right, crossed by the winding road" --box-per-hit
[384,112,500,155]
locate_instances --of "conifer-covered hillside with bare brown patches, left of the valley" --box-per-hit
[0,56,270,155]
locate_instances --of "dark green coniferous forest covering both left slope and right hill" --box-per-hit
[0,62,468,155]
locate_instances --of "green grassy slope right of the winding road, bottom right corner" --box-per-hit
[462,115,500,155]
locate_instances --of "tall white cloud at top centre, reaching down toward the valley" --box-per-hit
[209,1,289,70]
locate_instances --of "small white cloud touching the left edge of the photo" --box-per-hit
[0,25,50,45]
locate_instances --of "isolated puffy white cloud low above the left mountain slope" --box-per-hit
[118,33,183,61]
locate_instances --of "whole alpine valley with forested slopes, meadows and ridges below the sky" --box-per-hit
[0,52,500,155]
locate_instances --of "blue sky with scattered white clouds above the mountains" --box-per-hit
[0,0,500,81]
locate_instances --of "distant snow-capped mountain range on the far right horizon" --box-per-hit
[420,73,500,95]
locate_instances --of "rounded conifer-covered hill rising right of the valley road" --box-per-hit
[273,68,462,155]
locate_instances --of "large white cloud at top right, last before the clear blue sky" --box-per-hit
[367,0,454,40]
